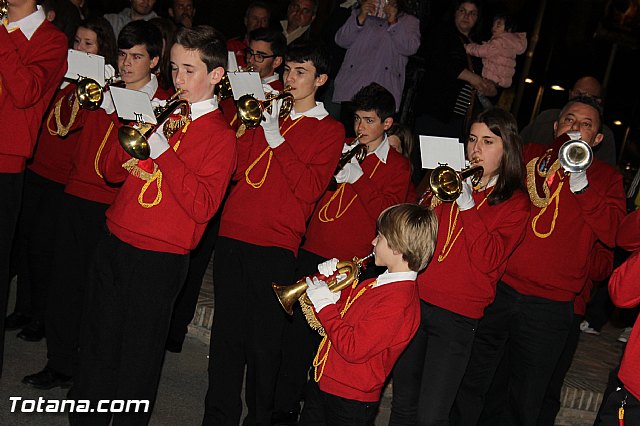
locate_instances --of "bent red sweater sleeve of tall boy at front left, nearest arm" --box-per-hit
[154,116,236,223]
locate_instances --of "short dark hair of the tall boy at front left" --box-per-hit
[175,25,228,72]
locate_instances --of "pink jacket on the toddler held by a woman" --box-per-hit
[465,32,527,88]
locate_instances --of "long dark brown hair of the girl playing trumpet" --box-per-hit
[465,108,525,206]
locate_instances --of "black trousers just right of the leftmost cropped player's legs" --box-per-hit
[14,169,64,321]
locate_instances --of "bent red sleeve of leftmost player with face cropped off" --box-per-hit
[0,22,67,109]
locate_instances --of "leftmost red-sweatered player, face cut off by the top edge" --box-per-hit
[0,0,67,375]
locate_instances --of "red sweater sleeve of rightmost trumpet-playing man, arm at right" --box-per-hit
[571,166,626,247]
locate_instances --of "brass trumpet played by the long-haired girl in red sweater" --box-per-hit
[418,161,484,206]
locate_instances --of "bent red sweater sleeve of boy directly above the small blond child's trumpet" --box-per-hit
[268,117,344,203]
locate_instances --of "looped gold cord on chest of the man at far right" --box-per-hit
[527,157,564,238]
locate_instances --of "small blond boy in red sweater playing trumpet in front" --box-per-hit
[299,204,438,425]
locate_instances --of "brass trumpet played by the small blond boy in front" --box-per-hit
[271,253,373,320]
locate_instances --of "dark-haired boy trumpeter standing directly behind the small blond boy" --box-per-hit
[275,83,411,420]
